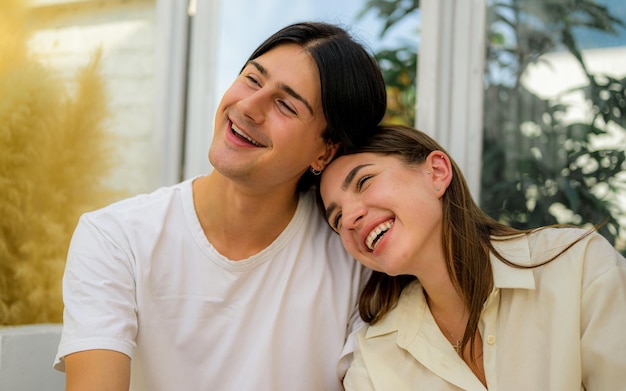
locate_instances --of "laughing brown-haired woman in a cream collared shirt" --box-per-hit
[320,126,626,391]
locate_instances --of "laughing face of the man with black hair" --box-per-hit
[209,44,329,194]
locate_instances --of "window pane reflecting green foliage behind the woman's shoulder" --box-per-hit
[481,0,626,252]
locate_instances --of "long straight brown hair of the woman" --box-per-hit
[324,125,593,357]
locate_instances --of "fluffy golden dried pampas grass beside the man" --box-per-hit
[0,0,119,325]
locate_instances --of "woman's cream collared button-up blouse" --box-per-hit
[344,228,626,391]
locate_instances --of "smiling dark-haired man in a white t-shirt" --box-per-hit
[55,23,386,391]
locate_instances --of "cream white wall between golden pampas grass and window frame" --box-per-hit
[30,0,162,194]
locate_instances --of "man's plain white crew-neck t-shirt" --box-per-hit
[54,180,365,391]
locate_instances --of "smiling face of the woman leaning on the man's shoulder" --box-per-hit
[320,152,448,275]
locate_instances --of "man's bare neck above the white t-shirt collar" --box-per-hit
[193,171,298,260]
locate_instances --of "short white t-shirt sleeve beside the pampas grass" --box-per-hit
[54,212,137,371]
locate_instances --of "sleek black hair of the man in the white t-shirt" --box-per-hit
[242,22,387,191]
